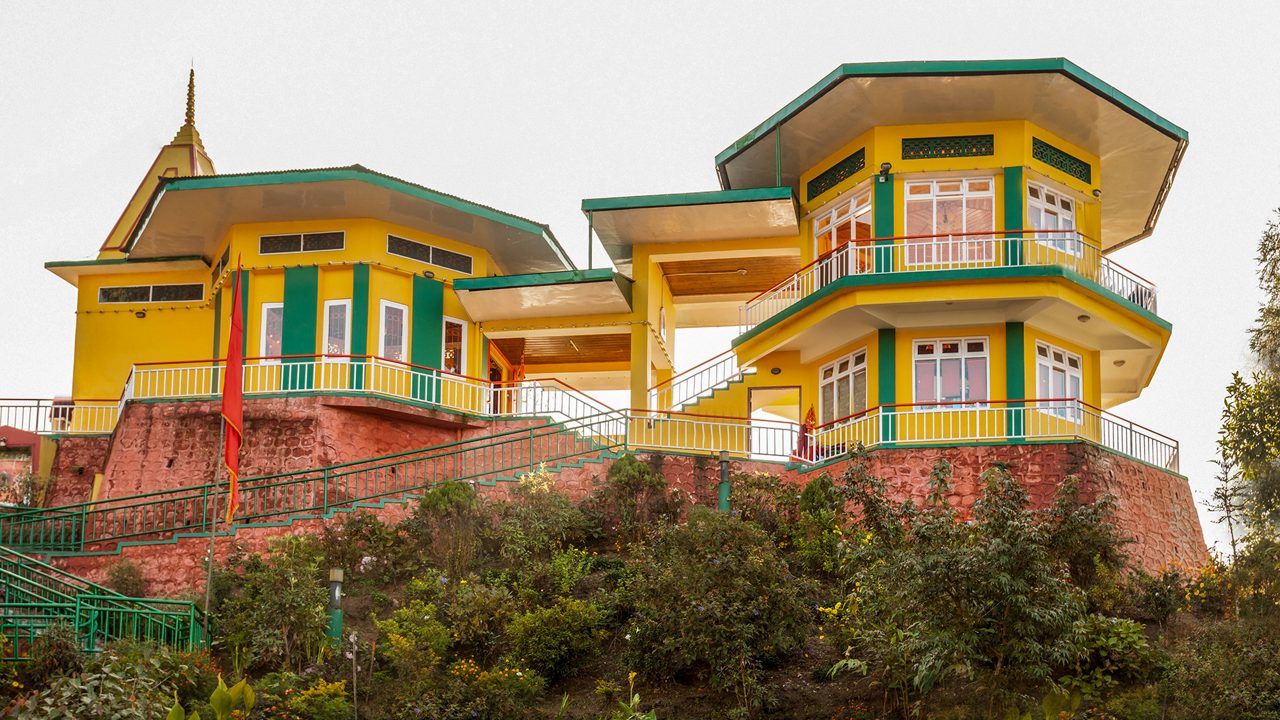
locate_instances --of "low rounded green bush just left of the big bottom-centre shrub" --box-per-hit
[507,598,604,680]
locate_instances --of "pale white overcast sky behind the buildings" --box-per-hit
[0,0,1280,541]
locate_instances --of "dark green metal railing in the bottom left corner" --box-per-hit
[0,547,204,660]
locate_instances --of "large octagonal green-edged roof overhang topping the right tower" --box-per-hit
[716,58,1188,250]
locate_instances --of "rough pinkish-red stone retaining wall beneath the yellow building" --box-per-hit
[37,397,1207,597]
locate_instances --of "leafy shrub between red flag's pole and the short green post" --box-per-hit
[216,537,329,670]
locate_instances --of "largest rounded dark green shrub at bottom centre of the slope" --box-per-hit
[626,507,812,710]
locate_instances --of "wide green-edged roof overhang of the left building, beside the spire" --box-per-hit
[125,165,573,273]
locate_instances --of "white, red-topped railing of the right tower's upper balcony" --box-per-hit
[740,231,1156,332]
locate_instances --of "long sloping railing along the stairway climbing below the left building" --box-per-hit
[0,413,627,553]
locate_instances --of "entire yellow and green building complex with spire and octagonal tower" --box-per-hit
[0,59,1204,564]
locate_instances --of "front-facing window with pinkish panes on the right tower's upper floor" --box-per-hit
[905,178,996,265]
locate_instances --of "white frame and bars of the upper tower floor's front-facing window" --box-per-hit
[902,176,997,265]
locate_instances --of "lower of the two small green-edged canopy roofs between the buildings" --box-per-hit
[453,269,632,323]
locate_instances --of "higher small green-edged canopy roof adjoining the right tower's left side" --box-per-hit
[582,187,800,275]
